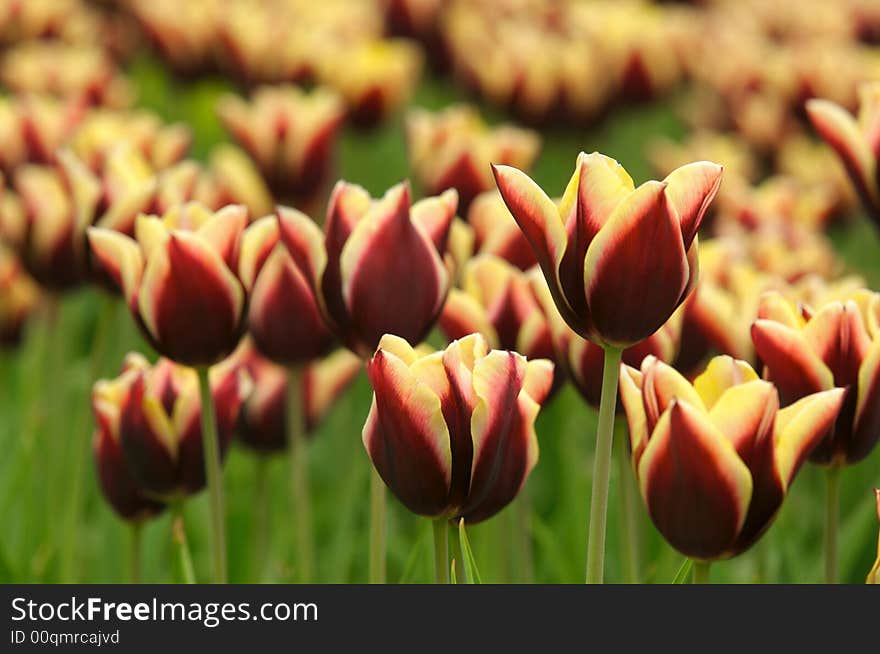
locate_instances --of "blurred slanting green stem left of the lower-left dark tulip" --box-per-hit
[60,296,117,583]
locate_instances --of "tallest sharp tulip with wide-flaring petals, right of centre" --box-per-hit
[493,153,721,347]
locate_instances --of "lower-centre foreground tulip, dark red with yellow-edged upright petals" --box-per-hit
[363,334,553,523]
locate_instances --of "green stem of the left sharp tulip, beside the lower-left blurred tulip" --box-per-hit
[197,367,226,584]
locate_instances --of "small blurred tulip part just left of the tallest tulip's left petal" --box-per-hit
[467,191,538,270]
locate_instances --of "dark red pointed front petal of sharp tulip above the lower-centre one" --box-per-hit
[340,185,449,350]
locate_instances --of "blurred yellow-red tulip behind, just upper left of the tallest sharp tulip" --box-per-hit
[406,105,540,212]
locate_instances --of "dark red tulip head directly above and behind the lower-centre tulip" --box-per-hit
[278,182,457,356]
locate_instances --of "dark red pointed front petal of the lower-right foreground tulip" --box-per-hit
[638,401,752,560]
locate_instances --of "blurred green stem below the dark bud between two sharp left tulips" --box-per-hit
[285,367,314,584]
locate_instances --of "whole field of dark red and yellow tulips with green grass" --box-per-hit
[0,0,880,584]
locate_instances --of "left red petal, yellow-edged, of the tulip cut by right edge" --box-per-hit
[752,320,834,406]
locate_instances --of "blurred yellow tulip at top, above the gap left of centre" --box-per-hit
[317,39,423,127]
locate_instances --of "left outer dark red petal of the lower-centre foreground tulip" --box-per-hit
[363,350,452,516]
